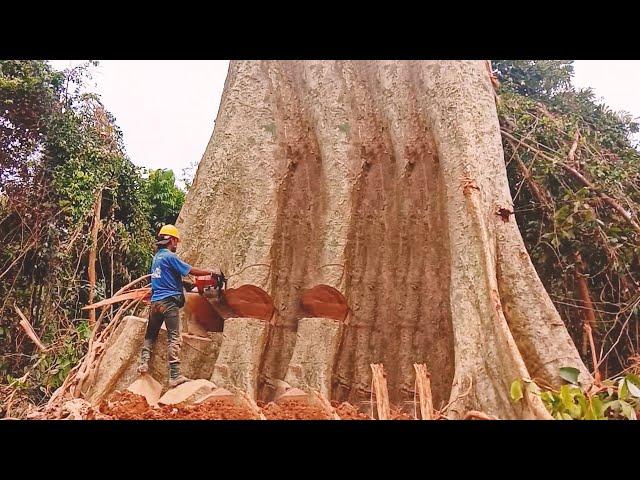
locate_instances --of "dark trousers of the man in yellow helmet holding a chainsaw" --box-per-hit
[142,297,182,378]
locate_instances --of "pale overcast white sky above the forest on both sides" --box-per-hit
[51,60,640,182]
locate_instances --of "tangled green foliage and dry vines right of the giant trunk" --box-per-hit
[493,60,640,376]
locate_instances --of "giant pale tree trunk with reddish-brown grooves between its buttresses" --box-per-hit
[178,61,590,418]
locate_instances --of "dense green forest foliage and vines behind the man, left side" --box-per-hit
[0,61,184,402]
